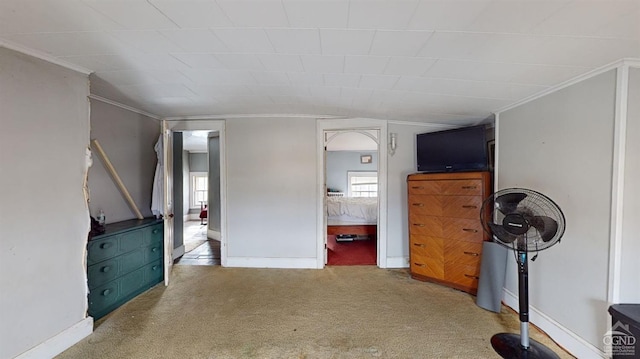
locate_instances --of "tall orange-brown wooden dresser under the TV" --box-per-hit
[407,172,491,294]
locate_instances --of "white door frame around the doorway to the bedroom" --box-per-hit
[316,118,388,268]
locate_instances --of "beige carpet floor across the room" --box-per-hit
[59,266,571,359]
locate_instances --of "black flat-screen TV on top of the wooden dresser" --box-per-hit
[416,125,488,172]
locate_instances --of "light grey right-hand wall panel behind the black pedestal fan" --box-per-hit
[496,71,616,348]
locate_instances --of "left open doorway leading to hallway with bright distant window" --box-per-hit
[163,120,226,282]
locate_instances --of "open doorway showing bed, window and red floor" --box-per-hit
[324,130,379,265]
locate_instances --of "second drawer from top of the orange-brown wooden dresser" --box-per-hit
[409,195,482,218]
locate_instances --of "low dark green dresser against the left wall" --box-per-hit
[87,218,164,319]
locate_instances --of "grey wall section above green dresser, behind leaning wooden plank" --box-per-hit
[89,100,160,223]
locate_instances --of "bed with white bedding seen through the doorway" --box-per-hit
[327,196,378,237]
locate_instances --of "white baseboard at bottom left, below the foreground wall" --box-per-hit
[16,317,93,359]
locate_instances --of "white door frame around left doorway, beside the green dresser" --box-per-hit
[162,119,227,267]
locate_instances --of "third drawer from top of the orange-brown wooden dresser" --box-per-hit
[409,217,485,242]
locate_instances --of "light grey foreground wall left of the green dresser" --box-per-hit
[0,48,92,358]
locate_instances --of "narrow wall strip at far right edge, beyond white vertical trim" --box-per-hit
[620,68,640,303]
